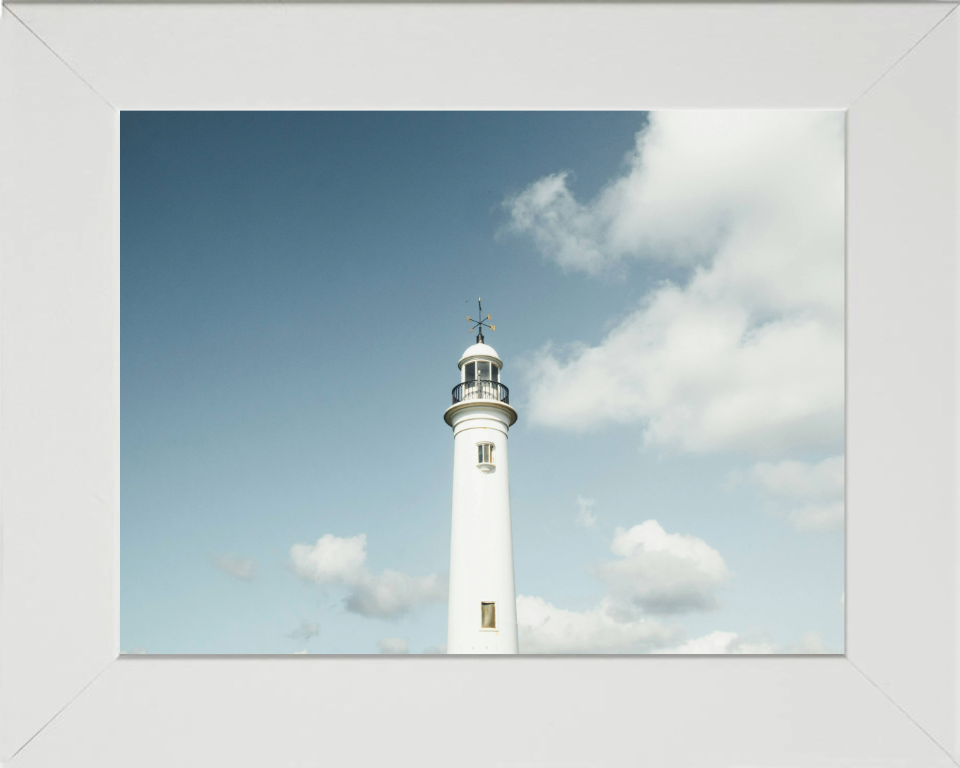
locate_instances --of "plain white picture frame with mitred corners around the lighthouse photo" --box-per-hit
[0,3,960,768]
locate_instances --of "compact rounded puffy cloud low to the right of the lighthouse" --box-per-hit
[597,520,730,614]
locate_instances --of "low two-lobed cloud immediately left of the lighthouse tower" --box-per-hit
[290,533,447,617]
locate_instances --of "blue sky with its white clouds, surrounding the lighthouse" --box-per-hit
[120,112,844,654]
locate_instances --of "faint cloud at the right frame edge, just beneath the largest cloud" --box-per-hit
[731,456,844,531]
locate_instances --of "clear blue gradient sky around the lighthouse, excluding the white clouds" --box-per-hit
[120,112,844,654]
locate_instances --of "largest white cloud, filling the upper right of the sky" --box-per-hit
[505,111,844,455]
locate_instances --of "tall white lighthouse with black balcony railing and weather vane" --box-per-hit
[443,299,519,653]
